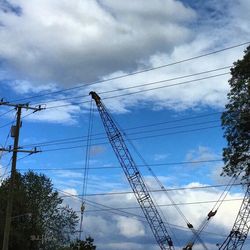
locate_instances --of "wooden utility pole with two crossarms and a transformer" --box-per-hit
[0,99,44,250]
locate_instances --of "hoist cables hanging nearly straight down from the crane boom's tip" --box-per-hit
[79,100,93,240]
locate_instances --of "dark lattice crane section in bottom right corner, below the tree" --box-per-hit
[219,183,250,250]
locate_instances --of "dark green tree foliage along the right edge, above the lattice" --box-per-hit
[221,46,250,181]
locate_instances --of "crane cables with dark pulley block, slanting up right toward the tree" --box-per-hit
[183,174,239,250]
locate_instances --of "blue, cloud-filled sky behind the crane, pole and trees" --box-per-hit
[0,0,250,250]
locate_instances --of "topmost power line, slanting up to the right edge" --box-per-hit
[10,41,250,102]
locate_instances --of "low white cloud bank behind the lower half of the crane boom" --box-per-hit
[60,180,247,250]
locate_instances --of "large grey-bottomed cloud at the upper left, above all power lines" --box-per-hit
[0,0,195,83]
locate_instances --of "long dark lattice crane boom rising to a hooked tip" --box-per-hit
[89,91,174,250]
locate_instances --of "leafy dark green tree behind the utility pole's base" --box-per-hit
[0,171,78,250]
